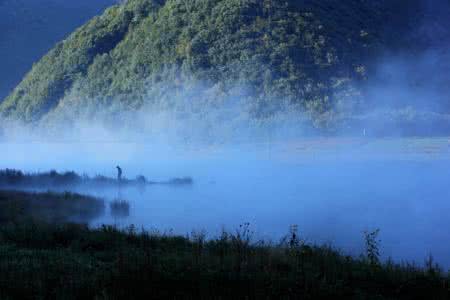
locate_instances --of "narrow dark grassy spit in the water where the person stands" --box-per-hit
[0,169,193,189]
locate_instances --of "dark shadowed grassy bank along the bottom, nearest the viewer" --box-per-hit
[0,194,450,299]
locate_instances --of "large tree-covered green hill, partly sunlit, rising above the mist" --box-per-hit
[0,0,446,127]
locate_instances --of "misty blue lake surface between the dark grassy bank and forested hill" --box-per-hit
[0,138,450,268]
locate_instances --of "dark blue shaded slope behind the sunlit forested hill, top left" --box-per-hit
[0,0,115,101]
